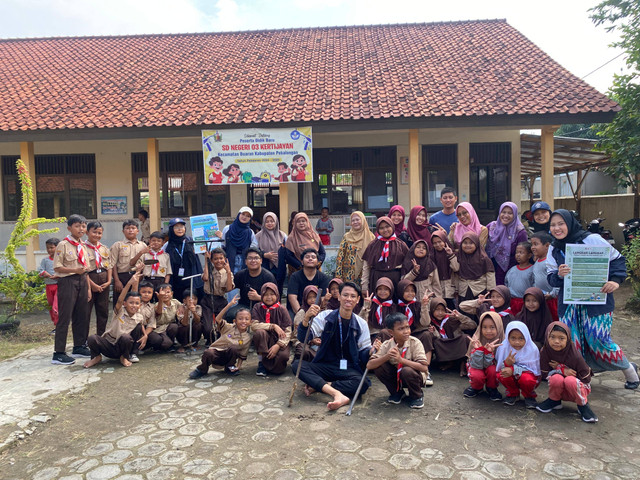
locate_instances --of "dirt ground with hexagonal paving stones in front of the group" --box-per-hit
[0,286,640,480]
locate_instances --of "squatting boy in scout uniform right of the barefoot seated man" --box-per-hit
[367,313,429,408]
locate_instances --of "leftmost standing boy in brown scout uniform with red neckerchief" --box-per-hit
[51,215,91,365]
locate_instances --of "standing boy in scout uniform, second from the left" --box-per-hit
[85,221,111,335]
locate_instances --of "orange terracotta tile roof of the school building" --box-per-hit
[0,20,618,131]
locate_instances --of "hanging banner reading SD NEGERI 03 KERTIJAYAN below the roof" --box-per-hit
[202,127,313,185]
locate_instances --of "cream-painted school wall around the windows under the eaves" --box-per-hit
[0,126,520,255]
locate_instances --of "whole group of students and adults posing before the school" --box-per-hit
[51,189,640,421]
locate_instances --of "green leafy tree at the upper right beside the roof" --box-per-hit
[590,0,640,217]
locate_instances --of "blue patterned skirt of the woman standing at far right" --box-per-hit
[561,304,629,372]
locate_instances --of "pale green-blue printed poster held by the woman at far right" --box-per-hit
[564,244,611,305]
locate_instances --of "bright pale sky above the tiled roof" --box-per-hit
[0,0,624,93]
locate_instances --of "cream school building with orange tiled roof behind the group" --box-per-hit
[0,20,619,268]
